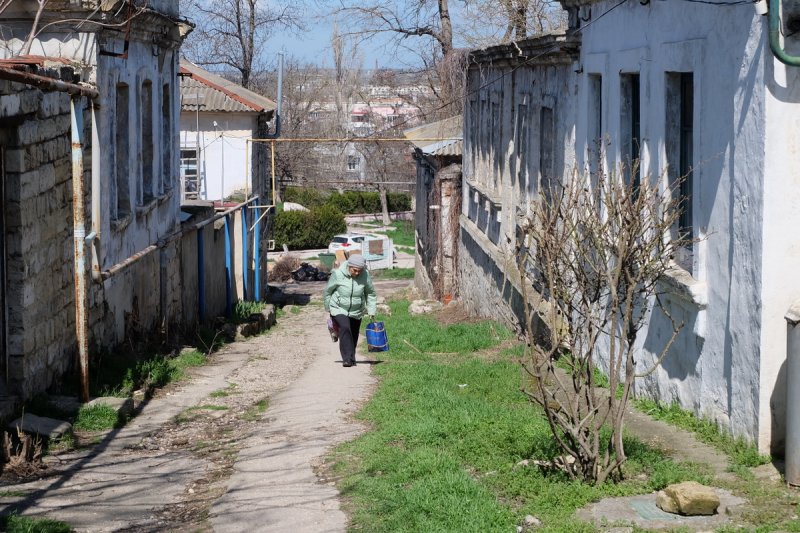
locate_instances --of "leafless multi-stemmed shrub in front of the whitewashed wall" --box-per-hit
[516,168,686,483]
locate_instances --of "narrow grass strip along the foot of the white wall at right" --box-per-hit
[634,399,771,467]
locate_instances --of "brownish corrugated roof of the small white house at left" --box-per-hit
[181,59,275,113]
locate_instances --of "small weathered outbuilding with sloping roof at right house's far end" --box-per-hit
[404,115,463,299]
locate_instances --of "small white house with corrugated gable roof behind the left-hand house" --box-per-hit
[180,59,275,200]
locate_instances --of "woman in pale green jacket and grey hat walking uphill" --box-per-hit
[325,254,378,366]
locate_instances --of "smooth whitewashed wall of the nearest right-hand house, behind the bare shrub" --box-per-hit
[577,2,800,451]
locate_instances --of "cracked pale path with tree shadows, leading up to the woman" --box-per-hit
[0,282,408,532]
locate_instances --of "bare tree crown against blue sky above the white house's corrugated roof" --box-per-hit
[184,0,302,88]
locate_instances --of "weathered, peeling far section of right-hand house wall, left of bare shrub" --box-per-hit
[457,48,577,325]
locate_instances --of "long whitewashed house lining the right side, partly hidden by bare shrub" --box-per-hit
[459,0,800,452]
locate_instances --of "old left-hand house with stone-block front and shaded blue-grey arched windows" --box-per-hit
[0,0,258,406]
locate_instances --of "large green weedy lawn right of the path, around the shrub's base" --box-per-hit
[332,301,710,532]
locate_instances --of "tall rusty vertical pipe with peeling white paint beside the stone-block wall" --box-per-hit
[70,95,94,402]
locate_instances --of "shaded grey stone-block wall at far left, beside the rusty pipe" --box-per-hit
[0,77,82,397]
